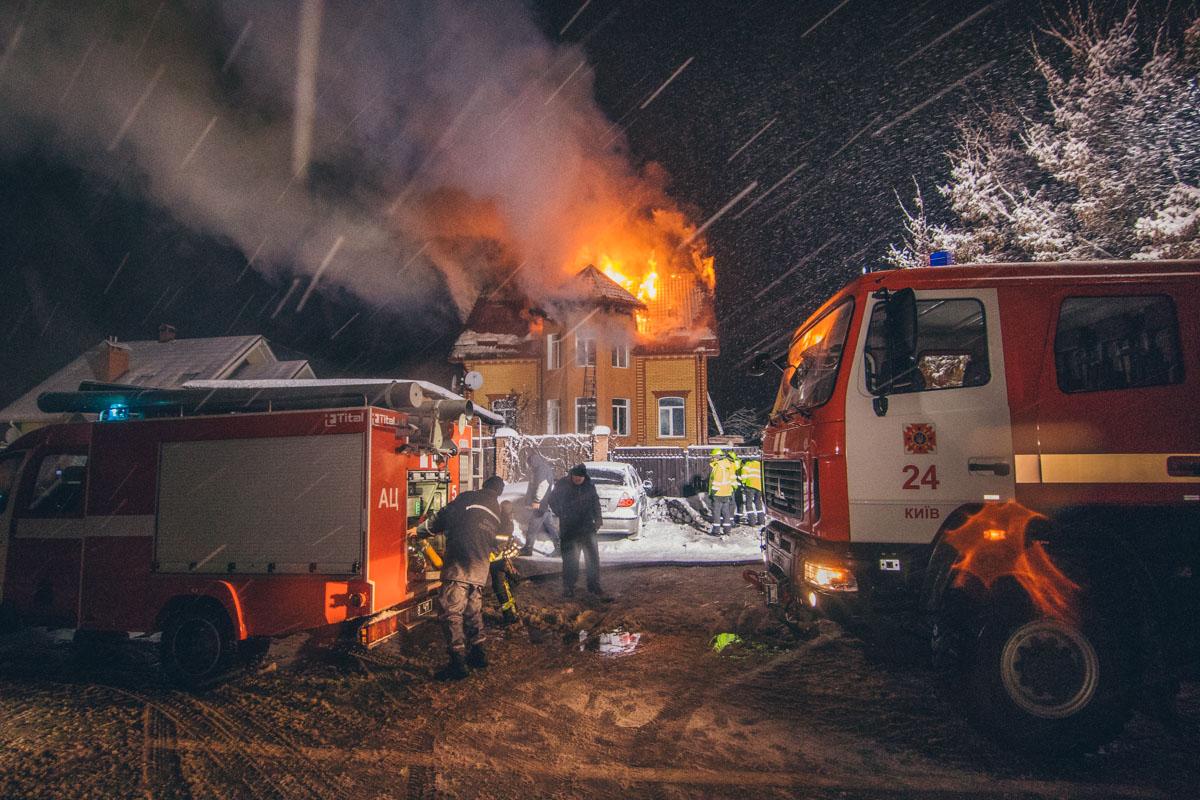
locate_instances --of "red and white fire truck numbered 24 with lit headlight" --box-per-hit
[746,261,1200,752]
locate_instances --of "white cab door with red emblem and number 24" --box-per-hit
[846,289,1014,543]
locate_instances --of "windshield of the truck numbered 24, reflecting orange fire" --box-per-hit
[773,300,854,414]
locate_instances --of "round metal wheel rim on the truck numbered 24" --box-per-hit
[1000,619,1100,720]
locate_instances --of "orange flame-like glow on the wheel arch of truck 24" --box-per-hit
[946,500,1079,621]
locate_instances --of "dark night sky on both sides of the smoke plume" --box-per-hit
[0,0,1180,413]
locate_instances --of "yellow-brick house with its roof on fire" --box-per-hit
[450,266,719,446]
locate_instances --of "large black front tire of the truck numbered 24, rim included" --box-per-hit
[967,609,1136,756]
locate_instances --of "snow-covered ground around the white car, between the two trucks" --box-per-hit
[503,482,762,566]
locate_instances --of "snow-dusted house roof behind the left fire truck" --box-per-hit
[0,336,278,422]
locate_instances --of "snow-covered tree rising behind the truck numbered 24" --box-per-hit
[887,7,1200,266]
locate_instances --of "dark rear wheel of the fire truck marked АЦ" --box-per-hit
[160,604,238,691]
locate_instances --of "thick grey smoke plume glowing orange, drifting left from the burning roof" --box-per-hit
[0,0,710,321]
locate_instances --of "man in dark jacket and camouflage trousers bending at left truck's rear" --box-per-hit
[428,475,512,680]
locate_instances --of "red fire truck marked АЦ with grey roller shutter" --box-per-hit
[0,381,473,687]
